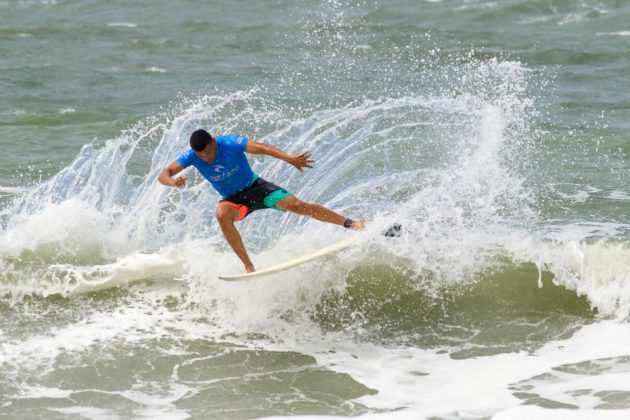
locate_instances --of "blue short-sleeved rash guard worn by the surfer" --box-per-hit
[175,136,258,198]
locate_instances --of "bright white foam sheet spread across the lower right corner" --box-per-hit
[272,321,630,419]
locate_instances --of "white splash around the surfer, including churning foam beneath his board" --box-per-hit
[0,53,628,324]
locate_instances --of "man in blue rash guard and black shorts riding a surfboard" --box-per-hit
[158,130,365,273]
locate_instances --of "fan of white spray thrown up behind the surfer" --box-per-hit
[3,55,544,306]
